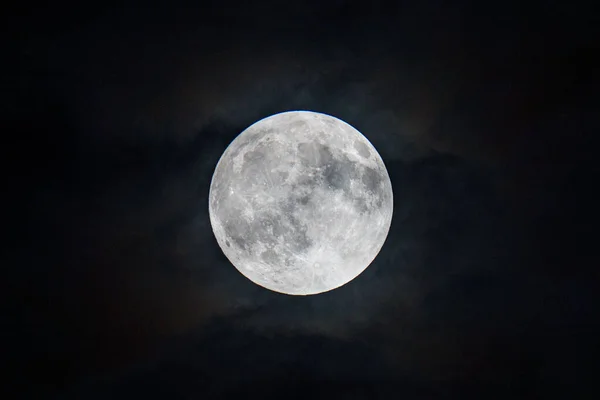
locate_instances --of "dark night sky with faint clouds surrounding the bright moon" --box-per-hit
[5,0,600,400]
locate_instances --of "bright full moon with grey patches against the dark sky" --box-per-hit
[209,111,393,295]
